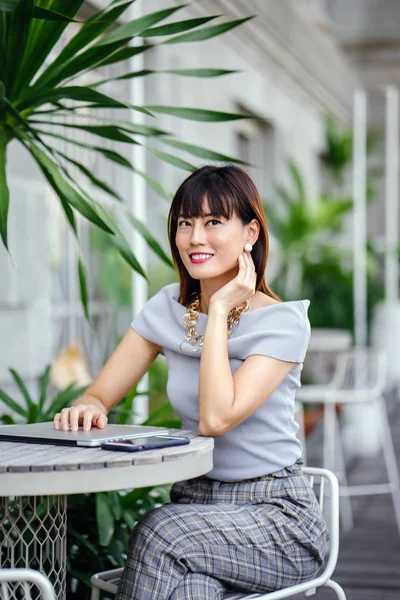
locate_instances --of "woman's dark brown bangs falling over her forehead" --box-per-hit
[173,172,239,219]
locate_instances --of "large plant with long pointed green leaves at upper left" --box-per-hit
[0,0,251,315]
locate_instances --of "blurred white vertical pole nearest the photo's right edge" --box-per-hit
[385,85,399,304]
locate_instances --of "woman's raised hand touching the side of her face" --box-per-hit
[210,251,257,314]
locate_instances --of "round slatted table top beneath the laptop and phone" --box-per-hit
[0,429,214,496]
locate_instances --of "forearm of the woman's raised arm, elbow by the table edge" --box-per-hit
[199,306,235,436]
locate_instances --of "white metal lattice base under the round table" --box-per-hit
[0,496,67,600]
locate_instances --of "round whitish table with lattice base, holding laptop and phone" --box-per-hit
[0,429,214,600]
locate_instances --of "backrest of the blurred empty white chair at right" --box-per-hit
[332,347,387,400]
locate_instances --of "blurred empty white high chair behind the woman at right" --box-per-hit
[296,348,400,533]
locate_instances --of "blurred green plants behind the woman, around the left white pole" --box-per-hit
[264,117,383,331]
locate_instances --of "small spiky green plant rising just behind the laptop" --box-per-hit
[0,365,86,425]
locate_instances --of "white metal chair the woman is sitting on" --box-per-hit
[91,467,346,600]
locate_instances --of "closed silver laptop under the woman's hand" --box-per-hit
[0,423,169,446]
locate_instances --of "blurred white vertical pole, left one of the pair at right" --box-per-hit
[353,89,367,346]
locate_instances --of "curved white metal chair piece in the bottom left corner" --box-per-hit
[0,569,56,600]
